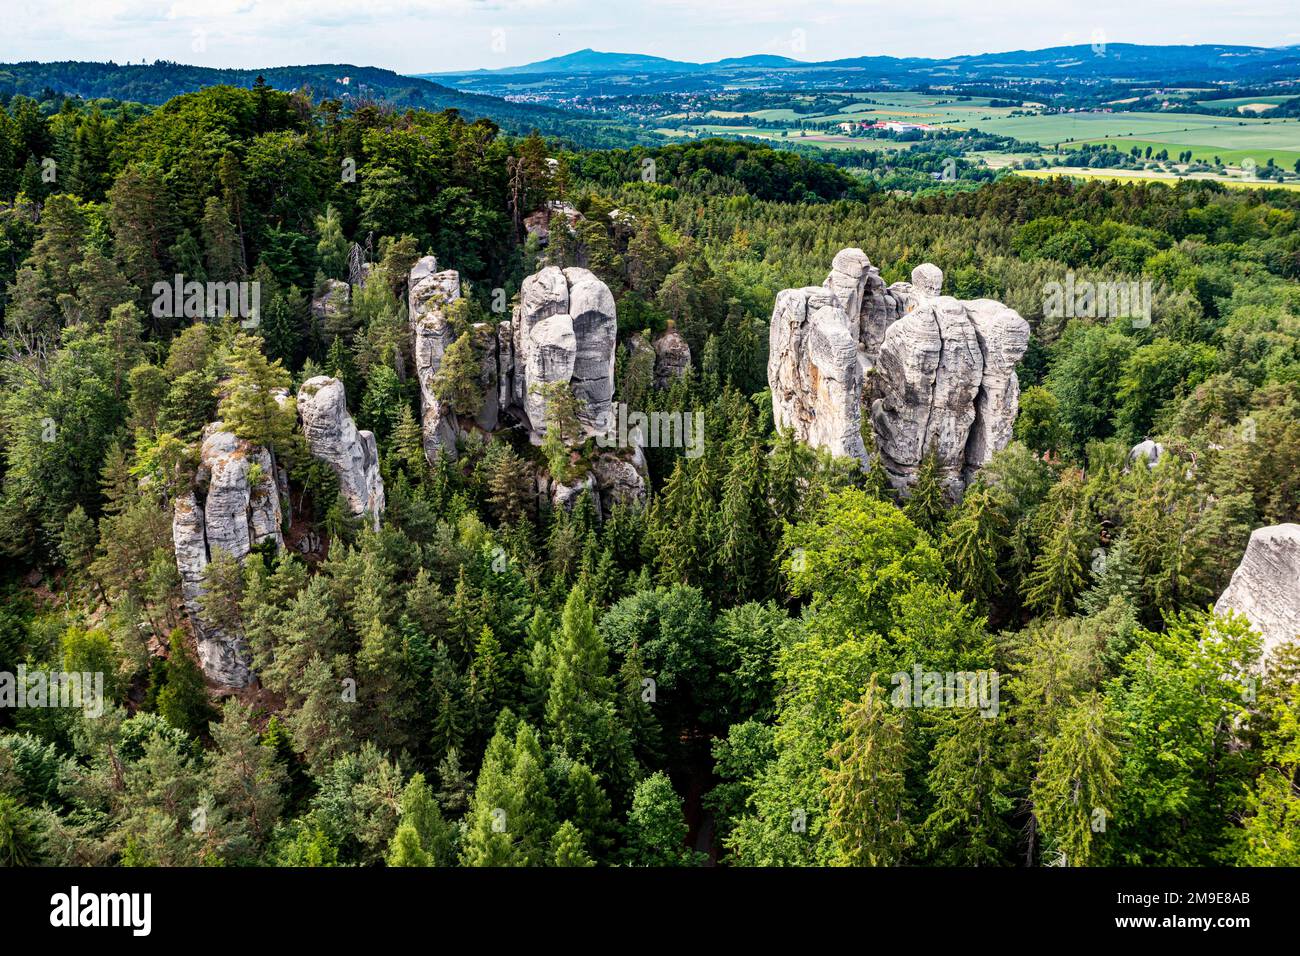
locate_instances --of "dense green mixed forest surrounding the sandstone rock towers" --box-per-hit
[0,83,1300,866]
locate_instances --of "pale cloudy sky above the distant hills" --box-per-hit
[0,0,1300,73]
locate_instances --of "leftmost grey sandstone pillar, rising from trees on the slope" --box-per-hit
[172,421,285,688]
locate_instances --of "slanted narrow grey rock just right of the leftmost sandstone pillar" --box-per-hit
[298,375,385,531]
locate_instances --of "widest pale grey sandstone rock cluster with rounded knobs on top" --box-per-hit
[767,248,1030,497]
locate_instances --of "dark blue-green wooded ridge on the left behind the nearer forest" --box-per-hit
[0,60,659,147]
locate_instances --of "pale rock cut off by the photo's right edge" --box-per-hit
[1214,524,1300,657]
